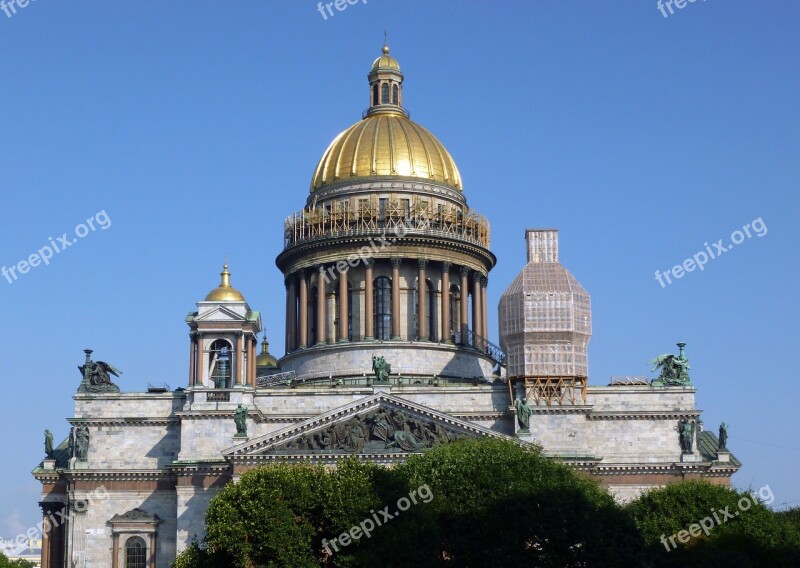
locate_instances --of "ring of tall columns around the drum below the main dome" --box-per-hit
[285,257,489,352]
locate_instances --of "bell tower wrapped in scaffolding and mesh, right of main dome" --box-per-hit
[499,229,592,404]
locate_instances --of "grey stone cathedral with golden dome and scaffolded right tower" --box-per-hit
[33,46,741,568]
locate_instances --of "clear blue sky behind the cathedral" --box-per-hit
[0,0,800,537]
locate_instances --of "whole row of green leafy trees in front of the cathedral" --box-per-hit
[172,439,800,568]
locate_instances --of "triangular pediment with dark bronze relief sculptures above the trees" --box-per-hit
[223,393,518,463]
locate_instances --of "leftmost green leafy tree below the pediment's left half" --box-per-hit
[191,458,380,568]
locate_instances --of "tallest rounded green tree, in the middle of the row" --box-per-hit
[386,439,641,568]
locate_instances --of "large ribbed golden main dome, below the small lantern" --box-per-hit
[311,111,461,191]
